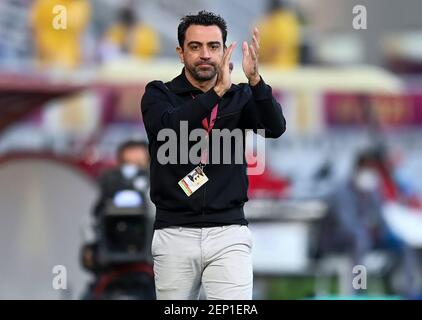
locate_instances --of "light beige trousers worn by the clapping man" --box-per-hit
[151,225,253,300]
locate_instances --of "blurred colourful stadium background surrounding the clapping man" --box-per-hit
[0,0,422,299]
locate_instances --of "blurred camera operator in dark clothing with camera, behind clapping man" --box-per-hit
[80,140,155,300]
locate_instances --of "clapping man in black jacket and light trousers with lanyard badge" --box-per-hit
[141,11,286,299]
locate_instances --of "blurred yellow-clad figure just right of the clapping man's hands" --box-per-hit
[258,2,301,69]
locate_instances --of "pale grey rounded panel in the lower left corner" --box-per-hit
[0,159,97,299]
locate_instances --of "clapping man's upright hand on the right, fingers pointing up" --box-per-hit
[242,27,261,86]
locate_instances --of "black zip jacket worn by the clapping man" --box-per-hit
[141,70,286,229]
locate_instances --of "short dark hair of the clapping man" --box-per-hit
[177,10,227,48]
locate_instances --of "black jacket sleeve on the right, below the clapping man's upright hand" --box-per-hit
[241,78,286,138]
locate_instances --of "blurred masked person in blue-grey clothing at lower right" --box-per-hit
[321,151,418,296]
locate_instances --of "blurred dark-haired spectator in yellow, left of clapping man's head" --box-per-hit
[100,6,160,60]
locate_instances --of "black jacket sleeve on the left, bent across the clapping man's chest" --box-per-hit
[141,81,220,136]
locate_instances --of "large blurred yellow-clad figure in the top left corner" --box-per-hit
[31,0,91,68]
